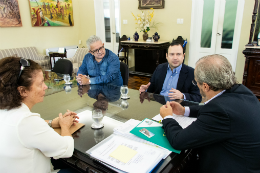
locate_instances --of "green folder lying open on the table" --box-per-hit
[130,118,181,154]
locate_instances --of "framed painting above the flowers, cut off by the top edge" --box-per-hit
[138,0,165,9]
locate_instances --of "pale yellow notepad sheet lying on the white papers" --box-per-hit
[109,145,137,163]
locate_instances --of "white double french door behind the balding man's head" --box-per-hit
[189,0,244,71]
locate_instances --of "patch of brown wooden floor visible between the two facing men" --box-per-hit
[128,75,150,90]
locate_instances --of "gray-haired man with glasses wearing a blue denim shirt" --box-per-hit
[77,35,123,86]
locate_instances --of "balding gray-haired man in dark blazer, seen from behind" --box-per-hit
[160,55,260,173]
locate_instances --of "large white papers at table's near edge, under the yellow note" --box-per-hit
[89,135,163,173]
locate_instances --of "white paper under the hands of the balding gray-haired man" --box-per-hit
[152,114,197,129]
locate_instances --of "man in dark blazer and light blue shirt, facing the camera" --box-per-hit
[139,41,201,102]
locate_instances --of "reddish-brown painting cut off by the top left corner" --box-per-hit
[0,0,22,27]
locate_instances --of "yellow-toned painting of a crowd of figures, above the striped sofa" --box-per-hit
[29,0,74,27]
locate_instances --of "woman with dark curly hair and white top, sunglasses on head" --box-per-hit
[0,57,78,173]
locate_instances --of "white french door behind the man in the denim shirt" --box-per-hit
[94,0,121,54]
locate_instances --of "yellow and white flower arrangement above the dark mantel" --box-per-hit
[132,8,155,32]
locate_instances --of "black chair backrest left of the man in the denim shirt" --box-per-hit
[52,59,73,76]
